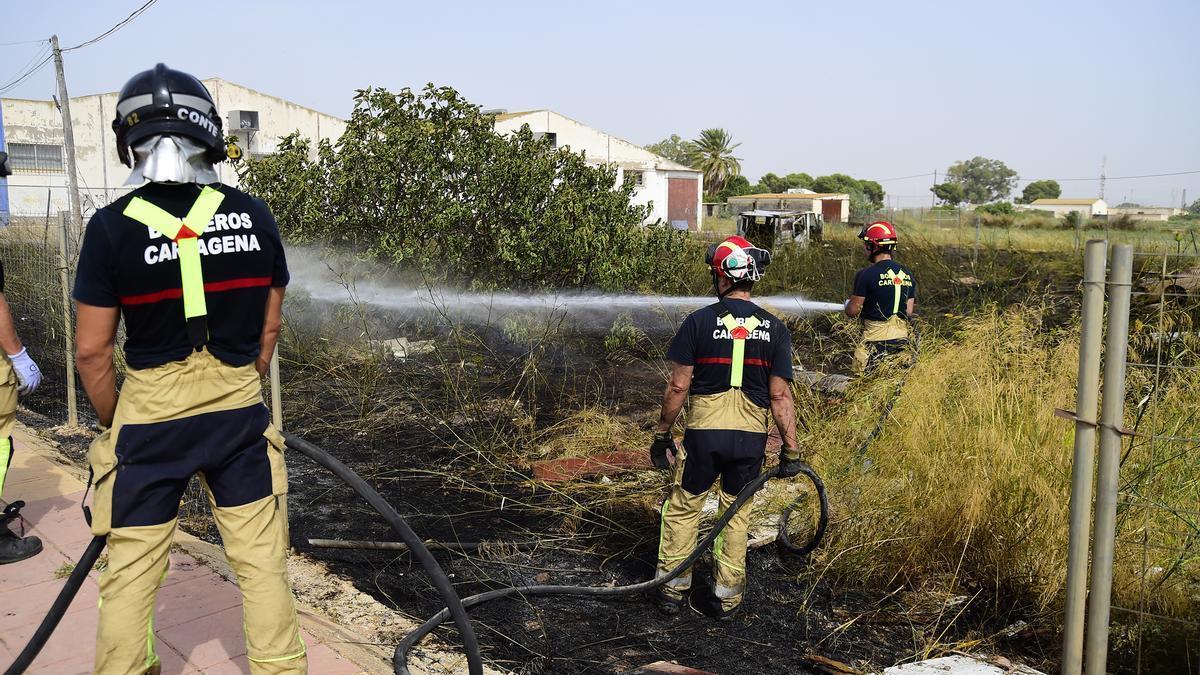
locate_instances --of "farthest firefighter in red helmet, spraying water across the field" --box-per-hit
[845,220,917,374]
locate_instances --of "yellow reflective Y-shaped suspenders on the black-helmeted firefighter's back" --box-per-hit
[124,186,224,347]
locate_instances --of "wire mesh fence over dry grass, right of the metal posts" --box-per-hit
[1109,252,1200,674]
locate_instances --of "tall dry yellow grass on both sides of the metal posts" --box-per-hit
[776,309,1200,623]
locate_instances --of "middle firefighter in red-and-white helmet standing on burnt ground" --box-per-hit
[650,237,802,619]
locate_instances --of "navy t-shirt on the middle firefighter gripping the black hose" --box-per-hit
[667,298,792,408]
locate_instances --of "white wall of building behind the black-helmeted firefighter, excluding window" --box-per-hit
[0,78,346,216]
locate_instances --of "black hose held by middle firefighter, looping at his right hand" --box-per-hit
[392,465,829,675]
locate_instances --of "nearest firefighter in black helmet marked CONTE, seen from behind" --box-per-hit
[74,64,307,675]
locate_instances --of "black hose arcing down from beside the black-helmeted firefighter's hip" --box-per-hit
[283,434,484,675]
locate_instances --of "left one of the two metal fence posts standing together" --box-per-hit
[1062,239,1108,675]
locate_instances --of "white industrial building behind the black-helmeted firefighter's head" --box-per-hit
[0,78,346,222]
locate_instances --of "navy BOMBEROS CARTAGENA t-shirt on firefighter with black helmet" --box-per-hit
[74,183,289,369]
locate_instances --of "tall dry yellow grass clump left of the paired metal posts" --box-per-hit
[796,310,1076,608]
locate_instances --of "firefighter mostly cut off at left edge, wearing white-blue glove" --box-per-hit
[0,153,42,565]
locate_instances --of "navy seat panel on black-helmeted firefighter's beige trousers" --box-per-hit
[113,405,271,527]
